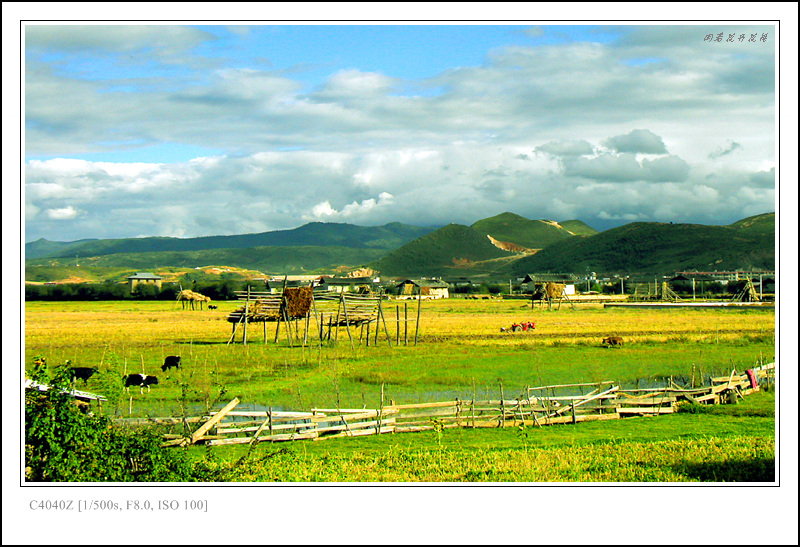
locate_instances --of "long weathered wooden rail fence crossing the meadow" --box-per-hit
[145,363,775,446]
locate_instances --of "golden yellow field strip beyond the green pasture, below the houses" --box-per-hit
[25,300,775,349]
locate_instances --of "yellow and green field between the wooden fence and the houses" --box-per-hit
[25,300,775,411]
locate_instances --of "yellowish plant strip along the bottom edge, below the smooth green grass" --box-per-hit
[194,437,775,482]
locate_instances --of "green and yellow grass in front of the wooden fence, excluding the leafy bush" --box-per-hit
[183,393,775,483]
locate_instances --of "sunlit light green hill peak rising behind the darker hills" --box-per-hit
[472,213,588,249]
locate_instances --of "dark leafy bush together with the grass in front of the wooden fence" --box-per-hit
[25,370,775,482]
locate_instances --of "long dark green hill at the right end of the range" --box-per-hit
[508,220,775,276]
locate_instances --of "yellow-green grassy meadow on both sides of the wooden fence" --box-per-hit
[25,299,775,482]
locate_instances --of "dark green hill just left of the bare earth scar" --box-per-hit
[369,224,511,276]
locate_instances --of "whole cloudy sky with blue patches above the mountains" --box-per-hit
[24,23,776,241]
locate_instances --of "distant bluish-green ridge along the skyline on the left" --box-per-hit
[25,222,434,258]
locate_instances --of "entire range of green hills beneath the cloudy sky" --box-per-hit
[25,212,775,282]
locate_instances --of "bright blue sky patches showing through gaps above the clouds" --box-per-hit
[26,24,624,162]
